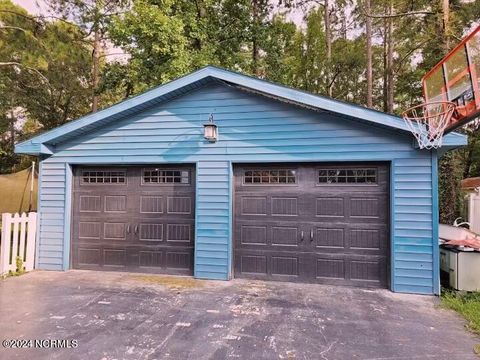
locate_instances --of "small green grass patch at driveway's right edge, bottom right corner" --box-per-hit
[442,290,480,336]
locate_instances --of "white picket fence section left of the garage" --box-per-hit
[0,212,37,276]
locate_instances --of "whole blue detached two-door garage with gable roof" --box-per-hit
[16,67,466,294]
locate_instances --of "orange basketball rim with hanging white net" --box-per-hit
[402,101,455,150]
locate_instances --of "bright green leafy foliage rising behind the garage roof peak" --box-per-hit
[104,0,256,96]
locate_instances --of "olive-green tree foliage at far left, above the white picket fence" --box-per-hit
[0,0,89,172]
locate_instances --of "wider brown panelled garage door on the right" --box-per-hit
[234,163,389,287]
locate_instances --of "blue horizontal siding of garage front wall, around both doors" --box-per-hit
[38,84,436,293]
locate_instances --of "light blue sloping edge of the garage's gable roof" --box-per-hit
[15,66,467,155]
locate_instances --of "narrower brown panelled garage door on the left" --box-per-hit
[72,166,195,275]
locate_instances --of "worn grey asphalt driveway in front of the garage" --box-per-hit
[0,271,480,360]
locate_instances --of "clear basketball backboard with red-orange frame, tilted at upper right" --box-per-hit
[422,26,480,133]
